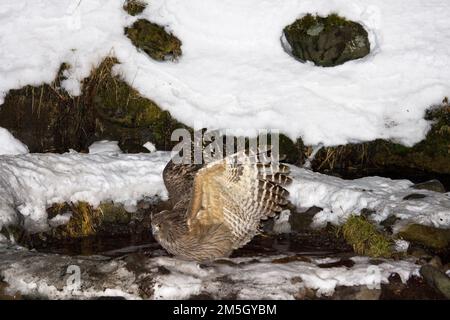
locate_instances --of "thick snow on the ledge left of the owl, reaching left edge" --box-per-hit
[0,152,170,232]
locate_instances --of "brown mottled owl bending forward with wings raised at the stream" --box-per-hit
[152,152,291,261]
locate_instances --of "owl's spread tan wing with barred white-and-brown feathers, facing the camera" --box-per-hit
[187,152,291,249]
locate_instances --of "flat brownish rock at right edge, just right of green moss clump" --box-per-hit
[398,224,450,249]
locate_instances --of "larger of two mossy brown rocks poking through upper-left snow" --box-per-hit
[125,19,181,61]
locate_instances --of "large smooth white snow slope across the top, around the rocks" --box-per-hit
[0,0,450,145]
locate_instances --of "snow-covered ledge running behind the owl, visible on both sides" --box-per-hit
[0,152,450,235]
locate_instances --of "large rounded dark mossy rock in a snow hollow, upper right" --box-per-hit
[284,14,370,67]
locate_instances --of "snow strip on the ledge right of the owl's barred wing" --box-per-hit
[288,166,450,232]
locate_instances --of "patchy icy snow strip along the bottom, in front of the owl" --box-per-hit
[0,247,420,299]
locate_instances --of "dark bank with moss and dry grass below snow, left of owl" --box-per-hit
[0,58,185,152]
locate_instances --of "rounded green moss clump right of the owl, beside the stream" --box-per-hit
[340,215,392,257]
